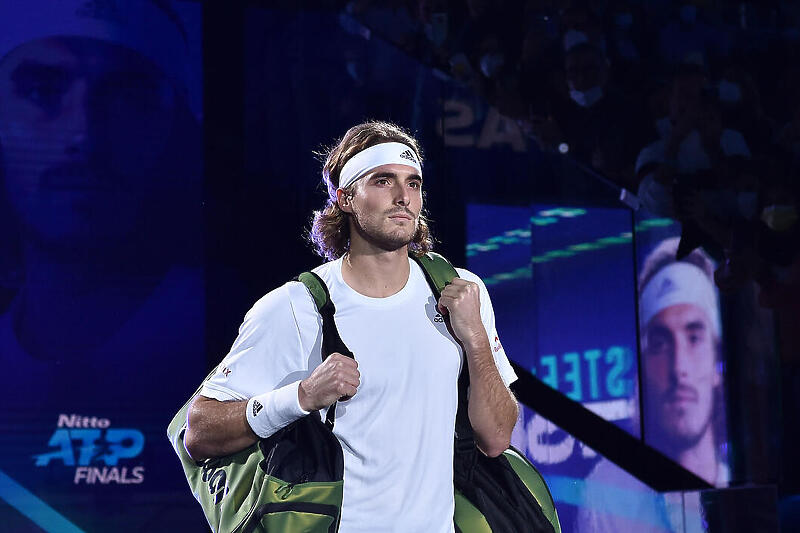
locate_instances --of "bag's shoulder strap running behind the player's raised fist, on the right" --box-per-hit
[411,252,475,450]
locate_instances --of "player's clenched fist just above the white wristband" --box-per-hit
[297,353,361,411]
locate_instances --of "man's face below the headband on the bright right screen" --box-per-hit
[643,303,720,452]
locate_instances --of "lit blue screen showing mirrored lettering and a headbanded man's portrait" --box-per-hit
[467,204,728,532]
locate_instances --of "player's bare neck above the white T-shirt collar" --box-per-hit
[342,246,410,298]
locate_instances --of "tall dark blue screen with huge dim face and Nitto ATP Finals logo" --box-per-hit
[0,0,205,531]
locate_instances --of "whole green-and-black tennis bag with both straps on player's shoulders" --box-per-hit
[167,253,561,533]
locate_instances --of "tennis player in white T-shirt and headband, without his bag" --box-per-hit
[185,121,518,533]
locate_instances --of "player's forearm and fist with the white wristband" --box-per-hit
[184,353,361,461]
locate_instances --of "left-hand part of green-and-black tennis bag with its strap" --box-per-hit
[167,272,353,533]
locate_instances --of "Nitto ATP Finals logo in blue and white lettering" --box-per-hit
[33,414,144,485]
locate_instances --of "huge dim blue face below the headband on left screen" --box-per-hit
[0,37,176,246]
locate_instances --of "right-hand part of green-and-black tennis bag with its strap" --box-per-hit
[412,252,561,533]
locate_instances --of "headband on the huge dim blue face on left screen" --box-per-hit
[0,0,189,108]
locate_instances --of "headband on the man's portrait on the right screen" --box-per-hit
[639,262,721,336]
